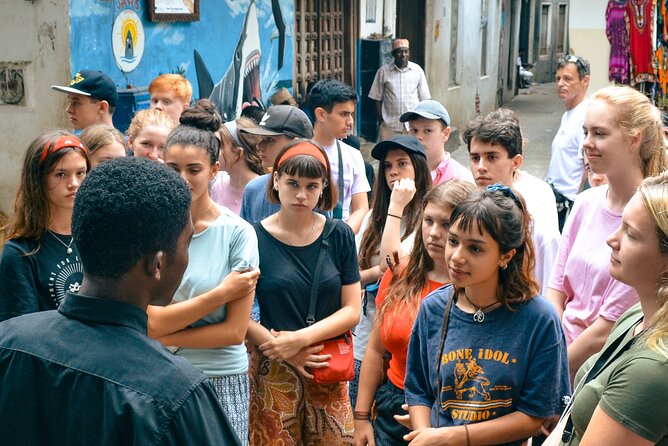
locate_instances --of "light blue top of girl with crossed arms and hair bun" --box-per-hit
[174,206,259,376]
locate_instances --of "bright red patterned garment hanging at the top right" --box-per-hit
[626,0,656,85]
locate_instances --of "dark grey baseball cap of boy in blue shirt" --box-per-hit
[239,105,313,138]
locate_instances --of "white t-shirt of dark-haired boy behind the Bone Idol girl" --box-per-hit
[513,170,561,295]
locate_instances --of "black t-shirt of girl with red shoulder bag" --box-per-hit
[253,220,360,331]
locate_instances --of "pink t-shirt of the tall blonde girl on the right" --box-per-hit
[549,185,638,344]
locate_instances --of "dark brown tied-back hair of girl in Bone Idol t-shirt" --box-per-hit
[450,189,538,309]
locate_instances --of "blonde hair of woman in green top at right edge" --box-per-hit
[638,172,668,358]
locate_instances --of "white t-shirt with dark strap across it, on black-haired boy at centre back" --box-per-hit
[323,141,371,221]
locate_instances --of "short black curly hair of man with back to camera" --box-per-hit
[72,157,191,279]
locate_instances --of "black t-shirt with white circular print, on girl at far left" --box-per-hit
[0,232,83,321]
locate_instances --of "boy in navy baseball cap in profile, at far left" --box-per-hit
[51,70,118,130]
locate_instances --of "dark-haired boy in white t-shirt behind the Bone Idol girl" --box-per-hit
[464,109,561,293]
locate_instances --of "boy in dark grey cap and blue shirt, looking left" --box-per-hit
[239,105,313,224]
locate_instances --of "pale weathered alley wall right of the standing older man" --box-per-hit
[423,0,501,138]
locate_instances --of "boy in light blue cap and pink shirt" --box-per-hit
[399,99,473,186]
